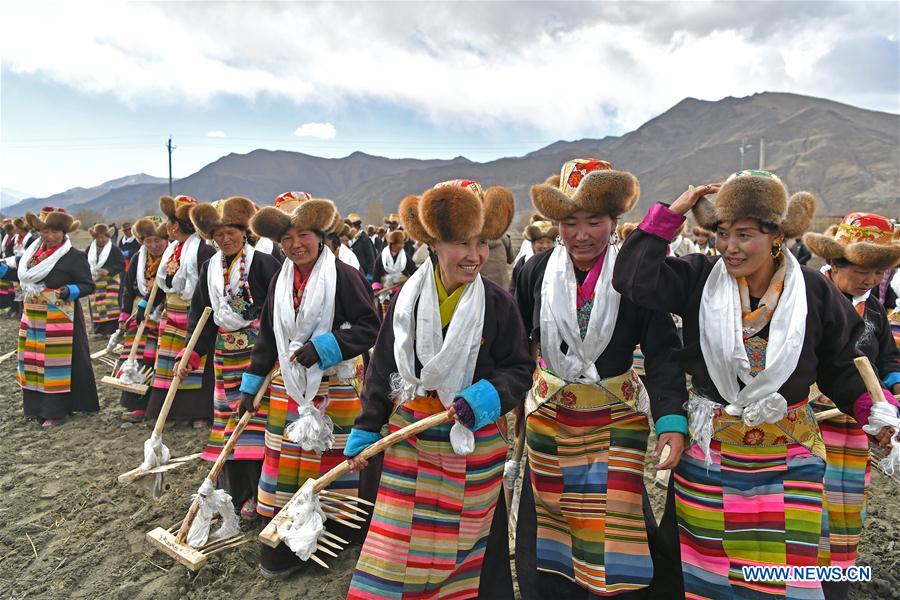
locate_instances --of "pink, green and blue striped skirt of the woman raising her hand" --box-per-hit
[674,404,825,600]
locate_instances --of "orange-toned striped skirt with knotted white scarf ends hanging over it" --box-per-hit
[256,375,361,519]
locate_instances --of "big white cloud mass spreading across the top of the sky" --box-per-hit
[0,2,900,137]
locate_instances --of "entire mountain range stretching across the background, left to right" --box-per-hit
[16,92,900,220]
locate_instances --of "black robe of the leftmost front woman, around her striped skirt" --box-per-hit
[3,247,100,419]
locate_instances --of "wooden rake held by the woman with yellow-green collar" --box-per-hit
[259,410,452,569]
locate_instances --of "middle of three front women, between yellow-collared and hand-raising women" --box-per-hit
[516,159,687,599]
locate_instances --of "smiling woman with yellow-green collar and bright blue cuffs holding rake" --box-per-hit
[344,182,532,599]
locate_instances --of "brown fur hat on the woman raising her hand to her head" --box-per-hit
[691,170,816,238]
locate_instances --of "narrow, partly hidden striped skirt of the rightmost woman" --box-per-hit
[814,396,872,568]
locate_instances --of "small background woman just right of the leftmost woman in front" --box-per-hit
[87,223,125,336]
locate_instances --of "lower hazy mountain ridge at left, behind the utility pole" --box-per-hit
[72,150,470,220]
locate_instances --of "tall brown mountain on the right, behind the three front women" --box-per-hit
[341,92,900,219]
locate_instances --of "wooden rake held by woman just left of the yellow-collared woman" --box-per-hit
[147,366,278,571]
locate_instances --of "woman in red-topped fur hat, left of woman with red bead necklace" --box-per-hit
[147,196,215,429]
